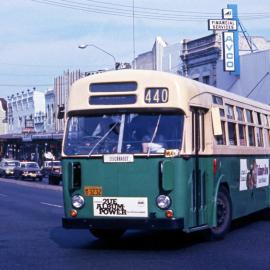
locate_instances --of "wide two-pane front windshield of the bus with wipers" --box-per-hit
[64,113,184,156]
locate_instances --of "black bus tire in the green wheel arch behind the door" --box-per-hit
[211,187,232,239]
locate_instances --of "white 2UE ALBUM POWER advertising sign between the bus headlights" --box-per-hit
[93,197,148,217]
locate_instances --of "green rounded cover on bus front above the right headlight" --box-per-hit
[161,160,175,191]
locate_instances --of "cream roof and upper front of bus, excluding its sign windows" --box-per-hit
[67,70,270,113]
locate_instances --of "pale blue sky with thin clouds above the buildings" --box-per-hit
[0,0,270,98]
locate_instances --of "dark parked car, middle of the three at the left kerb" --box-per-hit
[14,161,42,181]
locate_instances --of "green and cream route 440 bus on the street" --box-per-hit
[62,70,270,238]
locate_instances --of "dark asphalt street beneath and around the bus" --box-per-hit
[0,179,270,270]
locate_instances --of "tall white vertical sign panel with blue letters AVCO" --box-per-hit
[223,32,235,71]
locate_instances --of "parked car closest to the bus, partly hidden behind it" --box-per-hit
[42,160,62,185]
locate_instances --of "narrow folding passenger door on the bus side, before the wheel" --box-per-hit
[190,107,211,227]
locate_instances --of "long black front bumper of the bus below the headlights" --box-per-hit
[62,218,184,230]
